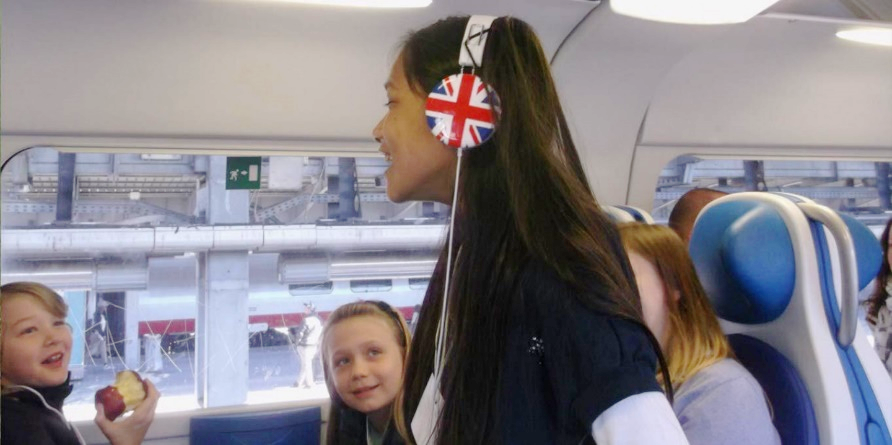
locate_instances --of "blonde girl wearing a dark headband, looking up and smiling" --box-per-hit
[322,301,410,445]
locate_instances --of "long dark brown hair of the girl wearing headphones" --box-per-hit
[401,17,659,445]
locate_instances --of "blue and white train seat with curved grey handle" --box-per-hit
[690,193,892,445]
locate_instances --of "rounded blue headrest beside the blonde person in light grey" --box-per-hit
[690,201,796,324]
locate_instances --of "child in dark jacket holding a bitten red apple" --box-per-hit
[0,282,160,445]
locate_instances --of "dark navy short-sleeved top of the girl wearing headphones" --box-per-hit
[498,267,661,445]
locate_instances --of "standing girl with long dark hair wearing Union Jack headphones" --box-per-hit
[374,16,686,445]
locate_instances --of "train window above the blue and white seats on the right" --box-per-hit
[652,156,892,229]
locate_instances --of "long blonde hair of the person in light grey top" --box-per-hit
[619,223,734,388]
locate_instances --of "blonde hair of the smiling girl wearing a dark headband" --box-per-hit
[321,300,412,445]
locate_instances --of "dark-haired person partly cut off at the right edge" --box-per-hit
[865,219,892,375]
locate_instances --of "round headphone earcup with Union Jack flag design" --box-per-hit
[425,73,499,148]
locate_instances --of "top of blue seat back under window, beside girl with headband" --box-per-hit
[189,406,322,445]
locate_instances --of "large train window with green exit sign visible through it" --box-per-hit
[0,147,448,420]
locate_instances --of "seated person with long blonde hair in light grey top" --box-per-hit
[620,223,780,445]
